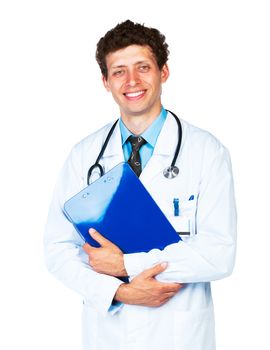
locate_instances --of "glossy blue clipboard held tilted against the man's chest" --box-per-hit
[64,163,181,253]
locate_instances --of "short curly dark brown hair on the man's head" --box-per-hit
[96,20,169,79]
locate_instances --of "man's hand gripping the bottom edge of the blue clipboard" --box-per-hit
[83,228,127,276]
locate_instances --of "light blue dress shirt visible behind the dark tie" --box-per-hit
[120,107,167,169]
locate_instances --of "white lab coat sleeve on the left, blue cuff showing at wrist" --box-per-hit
[44,148,123,314]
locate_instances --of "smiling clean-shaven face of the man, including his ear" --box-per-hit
[103,45,169,118]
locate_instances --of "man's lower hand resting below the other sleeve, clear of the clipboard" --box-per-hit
[114,263,184,307]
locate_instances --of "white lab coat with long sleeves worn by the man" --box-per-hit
[45,114,236,350]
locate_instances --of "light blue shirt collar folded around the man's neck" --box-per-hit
[119,107,167,148]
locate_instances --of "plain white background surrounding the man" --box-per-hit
[0,0,270,350]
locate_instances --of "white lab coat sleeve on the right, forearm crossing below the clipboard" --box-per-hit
[124,144,236,283]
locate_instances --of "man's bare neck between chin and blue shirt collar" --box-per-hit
[121,106,161,135]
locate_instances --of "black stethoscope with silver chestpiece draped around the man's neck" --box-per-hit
[87,109,182,185]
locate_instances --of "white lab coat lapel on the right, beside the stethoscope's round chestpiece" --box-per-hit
[140,112,178,185]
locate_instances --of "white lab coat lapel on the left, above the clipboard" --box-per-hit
[102,122,125,173]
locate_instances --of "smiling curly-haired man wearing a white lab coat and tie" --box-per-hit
[45,21,236,350]
